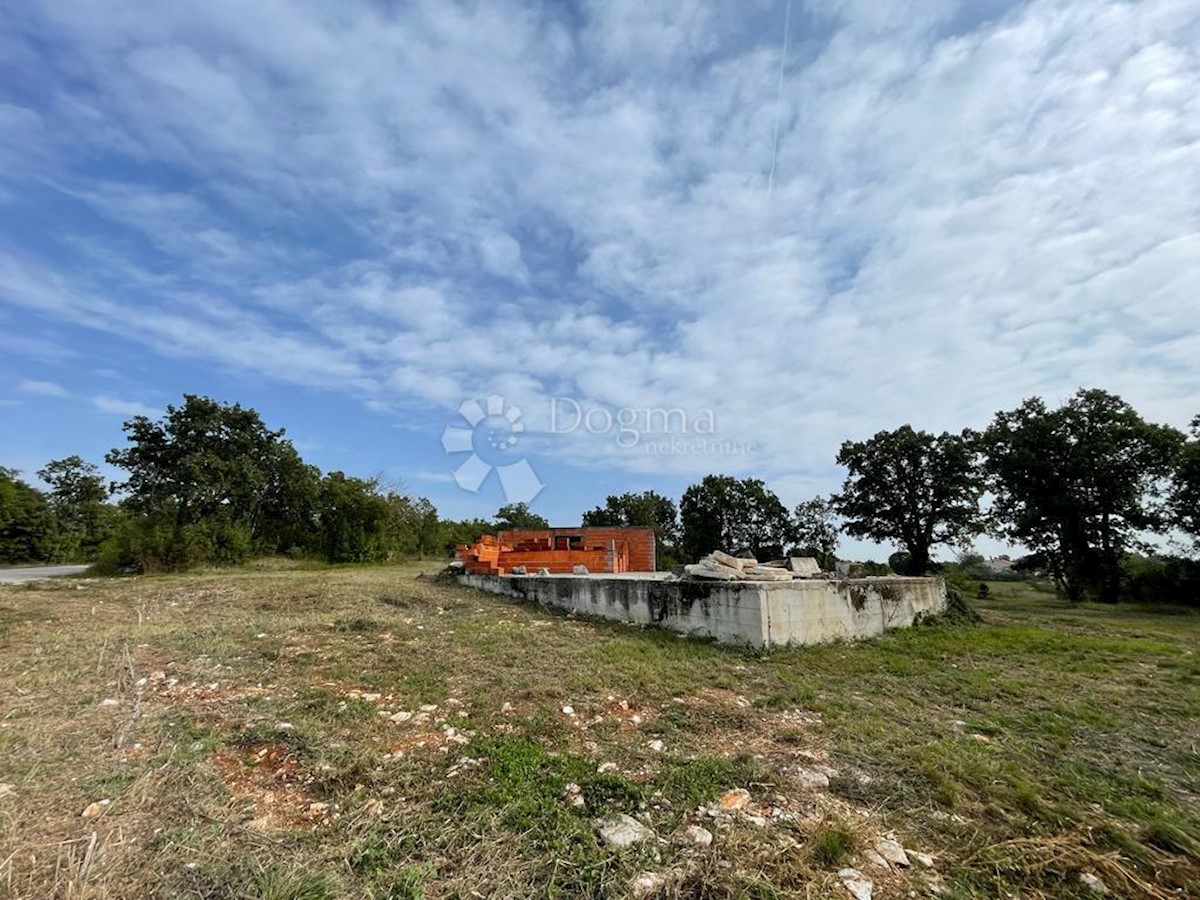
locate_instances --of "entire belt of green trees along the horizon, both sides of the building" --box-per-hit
[0,390,1200,601]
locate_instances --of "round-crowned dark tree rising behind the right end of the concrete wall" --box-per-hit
[833,425,983,575]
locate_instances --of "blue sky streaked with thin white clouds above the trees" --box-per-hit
[0,0,1200,561]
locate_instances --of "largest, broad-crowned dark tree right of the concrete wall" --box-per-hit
[983,390,1183,602]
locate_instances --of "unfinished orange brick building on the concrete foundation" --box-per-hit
[456,527,658,575]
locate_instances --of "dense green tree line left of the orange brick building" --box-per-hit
[0,395,484,571]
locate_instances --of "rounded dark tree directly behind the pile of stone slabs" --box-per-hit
[679,475,796,560]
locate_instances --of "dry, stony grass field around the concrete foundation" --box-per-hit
[0,564,1200,900]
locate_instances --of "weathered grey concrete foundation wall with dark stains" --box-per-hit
[458,575,946,647]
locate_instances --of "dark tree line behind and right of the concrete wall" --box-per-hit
[584,390,1200,602]
